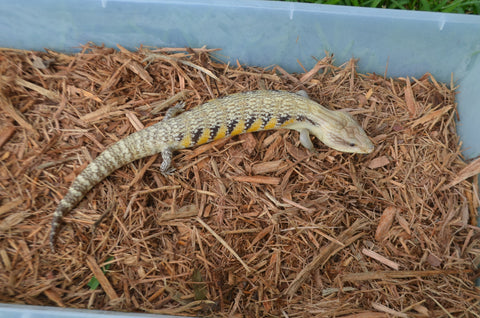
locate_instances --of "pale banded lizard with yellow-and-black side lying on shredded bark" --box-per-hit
[50,90,374,251]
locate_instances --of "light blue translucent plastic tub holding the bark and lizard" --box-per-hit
[0,0,480,318]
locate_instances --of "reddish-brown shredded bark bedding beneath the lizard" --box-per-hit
[0,44,480,317]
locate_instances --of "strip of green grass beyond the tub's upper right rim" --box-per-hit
[284,0,480,14]
